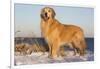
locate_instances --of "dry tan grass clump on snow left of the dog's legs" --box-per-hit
[15,44,46,55]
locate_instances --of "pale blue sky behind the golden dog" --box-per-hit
[14,3,94,37]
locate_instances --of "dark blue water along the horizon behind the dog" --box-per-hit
[15,37,94,52]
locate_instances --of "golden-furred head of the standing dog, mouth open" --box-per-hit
[40,7,55,20]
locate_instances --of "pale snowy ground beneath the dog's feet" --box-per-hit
[14,51,94,65]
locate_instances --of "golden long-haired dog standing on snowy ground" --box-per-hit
[40,7,87,58]
